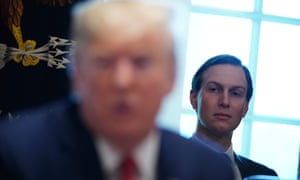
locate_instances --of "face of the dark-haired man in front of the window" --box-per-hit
[190,64,248,135]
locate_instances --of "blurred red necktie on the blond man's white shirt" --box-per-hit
[120,156,137,180]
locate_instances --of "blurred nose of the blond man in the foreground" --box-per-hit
[113,57,134,88]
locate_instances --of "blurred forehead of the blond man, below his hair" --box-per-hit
[81,27,173,60]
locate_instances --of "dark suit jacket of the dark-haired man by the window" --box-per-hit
[234,153,277,178]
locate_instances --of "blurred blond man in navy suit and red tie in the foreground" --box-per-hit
[0,1,233,180]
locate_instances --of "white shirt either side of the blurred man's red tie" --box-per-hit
[96,131,160,180]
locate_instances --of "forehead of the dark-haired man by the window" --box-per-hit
[202,64,247,87]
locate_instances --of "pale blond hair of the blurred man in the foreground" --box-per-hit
[75,1,169,41]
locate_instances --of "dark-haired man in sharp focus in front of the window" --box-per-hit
[190,54,277,179]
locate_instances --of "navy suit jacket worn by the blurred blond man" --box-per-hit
[0,99,233,180]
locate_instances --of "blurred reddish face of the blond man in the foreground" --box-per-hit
[74,23,175,142]
